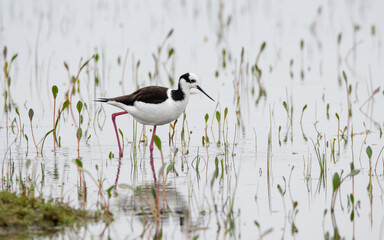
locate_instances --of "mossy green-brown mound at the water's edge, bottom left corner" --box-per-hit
[0,191,100,238]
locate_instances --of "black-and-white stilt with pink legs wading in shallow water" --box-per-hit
[95,73,214,157]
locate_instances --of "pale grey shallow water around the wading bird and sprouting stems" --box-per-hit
[0,0,384,239]
